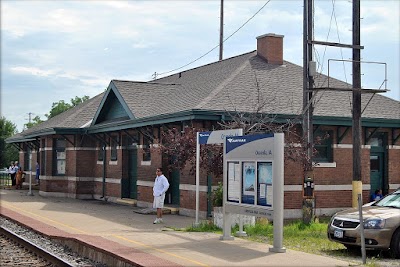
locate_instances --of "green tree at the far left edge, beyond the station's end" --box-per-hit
[0,117,18,168]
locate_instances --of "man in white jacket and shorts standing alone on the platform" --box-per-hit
[153,168,169,224]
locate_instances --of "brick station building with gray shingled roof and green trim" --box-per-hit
[6,34,400,218]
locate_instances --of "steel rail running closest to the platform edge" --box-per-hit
[0,226,76,267]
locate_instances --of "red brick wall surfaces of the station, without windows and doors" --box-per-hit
[15,122,400,219]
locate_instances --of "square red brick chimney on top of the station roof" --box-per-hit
[257,33,284,65]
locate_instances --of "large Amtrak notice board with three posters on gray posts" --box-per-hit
[221,133,286,252]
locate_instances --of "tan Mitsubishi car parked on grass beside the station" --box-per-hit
[328,188,400,258]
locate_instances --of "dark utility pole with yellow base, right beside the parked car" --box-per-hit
[352,0,362,208]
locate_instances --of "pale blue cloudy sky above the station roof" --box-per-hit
[0,0,400,132]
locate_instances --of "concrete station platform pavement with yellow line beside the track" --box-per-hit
[0,189,354,267]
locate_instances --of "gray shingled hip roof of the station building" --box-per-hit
[7,51,400,142]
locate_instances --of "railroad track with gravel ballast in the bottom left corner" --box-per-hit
[0,226,76,267]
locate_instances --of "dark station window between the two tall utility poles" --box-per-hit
[313,131,333,162]
